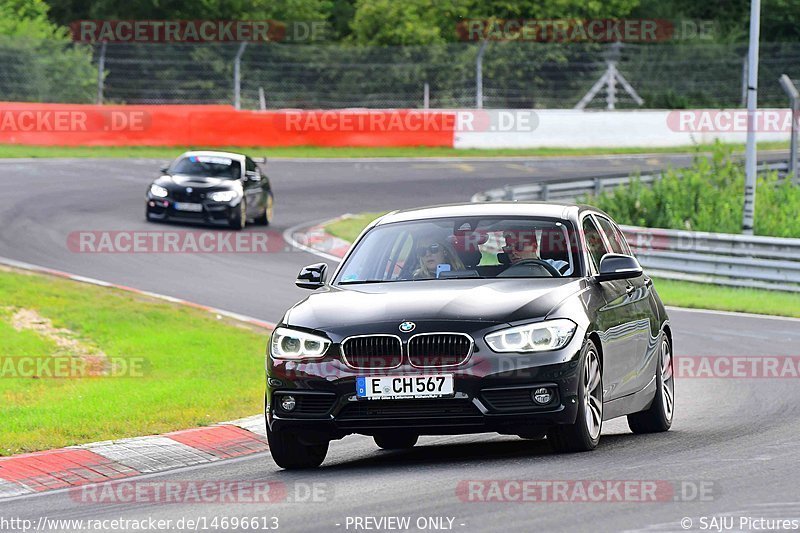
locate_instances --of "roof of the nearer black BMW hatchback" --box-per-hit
[377,202,602,225]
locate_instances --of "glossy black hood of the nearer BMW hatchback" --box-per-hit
[285,278,583,331]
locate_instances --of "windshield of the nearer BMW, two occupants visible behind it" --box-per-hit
[335,217,581,285]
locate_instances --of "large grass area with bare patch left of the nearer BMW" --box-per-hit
[0,270,267,455]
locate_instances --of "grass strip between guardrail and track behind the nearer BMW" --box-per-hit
[325,213,800,318]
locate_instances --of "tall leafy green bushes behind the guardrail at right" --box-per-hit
[582,146,800,237]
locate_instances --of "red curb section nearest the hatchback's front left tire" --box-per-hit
[164,425,268,459]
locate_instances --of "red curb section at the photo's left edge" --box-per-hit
[0,449,139,492]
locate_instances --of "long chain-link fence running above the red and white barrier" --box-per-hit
[0,41,800,109]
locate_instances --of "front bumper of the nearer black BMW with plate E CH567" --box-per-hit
[265,339,582,442]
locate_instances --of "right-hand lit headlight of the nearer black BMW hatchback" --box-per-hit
[486,318,577,352]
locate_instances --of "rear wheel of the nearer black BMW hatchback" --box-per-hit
[628,334,675,434]
